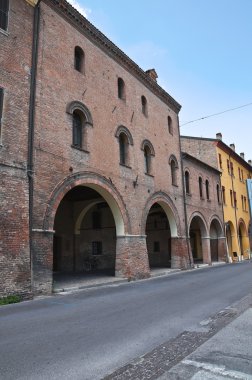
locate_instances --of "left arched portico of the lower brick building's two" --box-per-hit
[188,213,211,264]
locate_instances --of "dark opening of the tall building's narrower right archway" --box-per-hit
[146,203,171,269]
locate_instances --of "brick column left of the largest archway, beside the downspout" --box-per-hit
[32,229,54,294]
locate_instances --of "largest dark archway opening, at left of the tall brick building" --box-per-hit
[53,186,116,279]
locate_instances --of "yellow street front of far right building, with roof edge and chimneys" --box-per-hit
[216,134,252,261]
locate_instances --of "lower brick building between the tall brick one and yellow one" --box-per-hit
[181,151,227,264]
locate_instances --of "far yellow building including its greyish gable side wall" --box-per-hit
[181,133,252,260]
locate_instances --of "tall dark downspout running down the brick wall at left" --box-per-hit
[27,0,41,284]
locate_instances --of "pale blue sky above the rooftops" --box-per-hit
[68,0,252,160]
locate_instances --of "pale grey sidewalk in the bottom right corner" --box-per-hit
[158,308,252,380]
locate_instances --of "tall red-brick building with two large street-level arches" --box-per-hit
[0,0,191,294]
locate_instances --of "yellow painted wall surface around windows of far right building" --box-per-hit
[216,144,252,260]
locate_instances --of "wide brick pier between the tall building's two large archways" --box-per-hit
[115,235,150,279]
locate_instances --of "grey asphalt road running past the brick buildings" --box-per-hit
[0,262,252,380]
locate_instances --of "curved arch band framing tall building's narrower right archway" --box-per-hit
[141,191,181,237]
